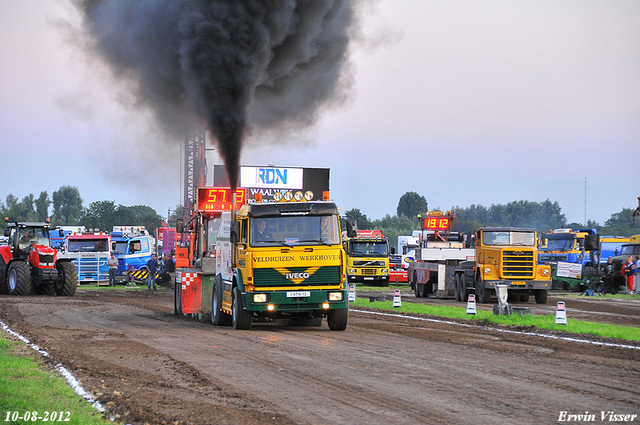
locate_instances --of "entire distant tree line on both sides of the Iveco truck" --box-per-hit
[0,186,640,246]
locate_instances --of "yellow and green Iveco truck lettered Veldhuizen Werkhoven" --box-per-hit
[208,187,349,330]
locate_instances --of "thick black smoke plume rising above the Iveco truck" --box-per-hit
[74,0,359,188]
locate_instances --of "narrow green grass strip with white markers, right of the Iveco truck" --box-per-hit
[351,296,640,341]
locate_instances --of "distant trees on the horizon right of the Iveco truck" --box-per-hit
[342,192,640,250]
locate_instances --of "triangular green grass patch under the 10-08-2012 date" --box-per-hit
[0,335,106,425]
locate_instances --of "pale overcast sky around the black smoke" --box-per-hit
[0,0,640,224]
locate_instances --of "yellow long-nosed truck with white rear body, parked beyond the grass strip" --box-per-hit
[408,220,551,304]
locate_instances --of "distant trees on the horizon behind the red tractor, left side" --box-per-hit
[0,186,163,234]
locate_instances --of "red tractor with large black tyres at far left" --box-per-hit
[0,219,78,297]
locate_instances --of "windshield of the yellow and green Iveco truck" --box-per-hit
[250,215,340,246]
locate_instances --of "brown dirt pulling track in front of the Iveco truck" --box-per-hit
[0,288,640,424]
